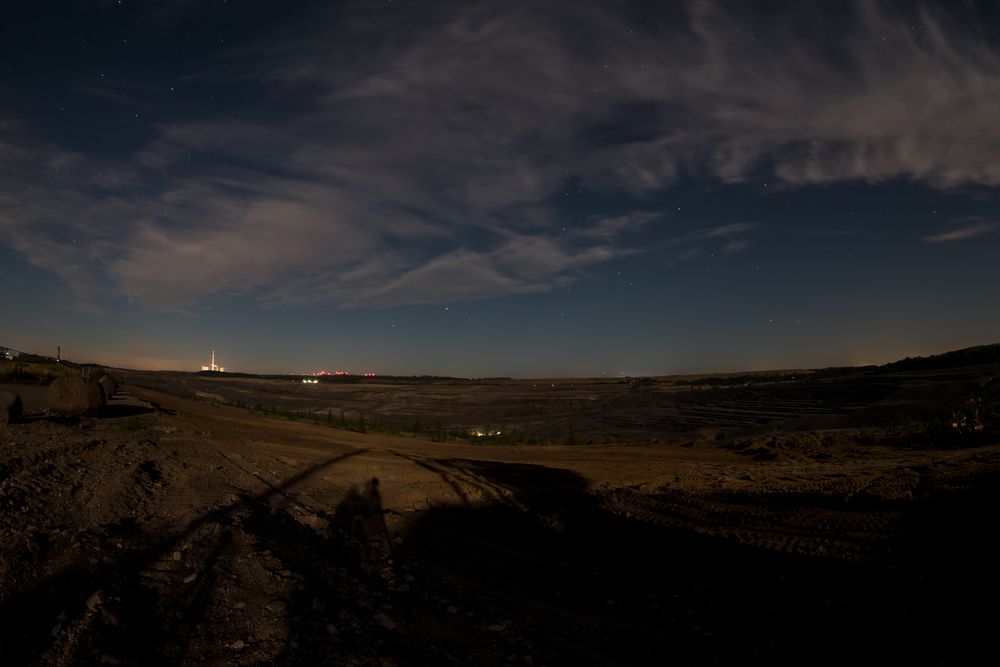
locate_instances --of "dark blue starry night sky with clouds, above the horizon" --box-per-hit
[0,0,1000,377]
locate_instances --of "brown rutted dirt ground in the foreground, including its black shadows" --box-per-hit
[0,387,1000,666]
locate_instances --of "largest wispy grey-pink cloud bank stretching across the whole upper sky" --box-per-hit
[0,0,1000,309]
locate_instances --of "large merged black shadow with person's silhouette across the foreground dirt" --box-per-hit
[0,450,1000,665]
